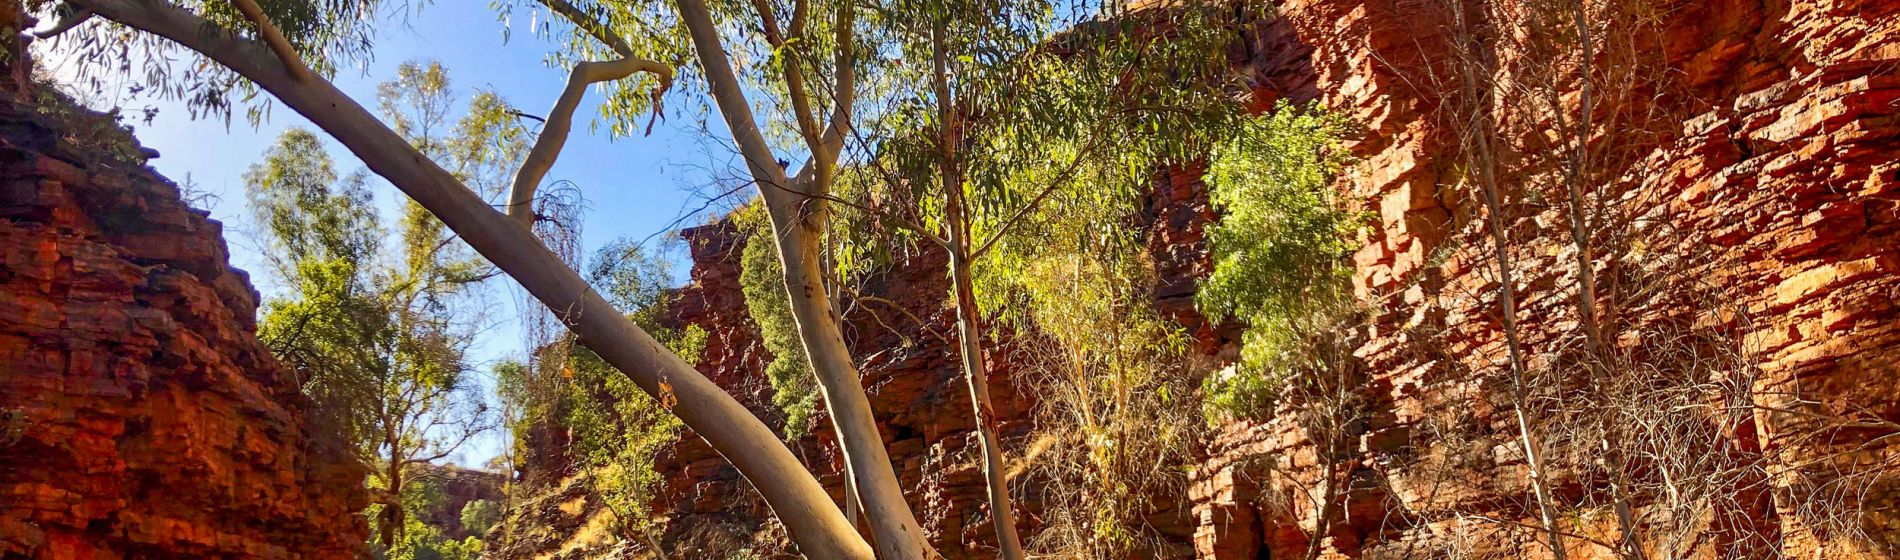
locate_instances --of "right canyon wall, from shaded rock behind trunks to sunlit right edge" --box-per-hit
[509,0,1900,558]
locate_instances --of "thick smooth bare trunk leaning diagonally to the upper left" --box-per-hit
[74,0,872,560]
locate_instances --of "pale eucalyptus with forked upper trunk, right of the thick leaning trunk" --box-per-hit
[497,0,937,558]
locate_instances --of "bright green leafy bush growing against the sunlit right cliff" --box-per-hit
[1195,103,1364,418]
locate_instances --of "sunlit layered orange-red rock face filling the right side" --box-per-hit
[1193,0,1900,558]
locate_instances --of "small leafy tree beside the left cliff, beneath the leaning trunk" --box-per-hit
[245,129,488,549]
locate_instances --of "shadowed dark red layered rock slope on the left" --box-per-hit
[0,101,367,558]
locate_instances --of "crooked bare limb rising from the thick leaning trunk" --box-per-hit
[507,59,673,228]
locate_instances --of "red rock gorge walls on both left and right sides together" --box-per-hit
[0,0,1900,560]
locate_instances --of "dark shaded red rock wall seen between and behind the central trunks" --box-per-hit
[502,220,1064,558]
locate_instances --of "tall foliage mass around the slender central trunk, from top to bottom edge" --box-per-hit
[809,0,1269,558]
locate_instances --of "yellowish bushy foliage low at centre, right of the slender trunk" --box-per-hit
[1013,236,1201,558]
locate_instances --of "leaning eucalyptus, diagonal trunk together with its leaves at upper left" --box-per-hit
[44,0,870,558]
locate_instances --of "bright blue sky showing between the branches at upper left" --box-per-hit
[42,0,751,465]
